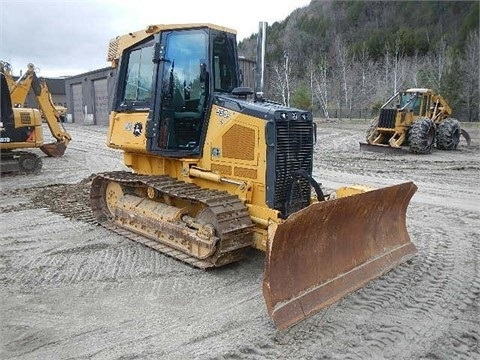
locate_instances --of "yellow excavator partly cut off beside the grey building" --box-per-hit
[0,62,72,173]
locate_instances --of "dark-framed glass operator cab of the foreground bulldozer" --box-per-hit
[114,27,239,157]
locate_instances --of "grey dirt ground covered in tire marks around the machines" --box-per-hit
[0,121,480,359]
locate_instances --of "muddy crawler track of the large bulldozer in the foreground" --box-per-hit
[90,171,253,269]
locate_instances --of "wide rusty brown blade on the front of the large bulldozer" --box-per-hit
[263,182,417,329]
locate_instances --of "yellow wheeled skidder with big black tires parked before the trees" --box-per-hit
[360,88,471,154]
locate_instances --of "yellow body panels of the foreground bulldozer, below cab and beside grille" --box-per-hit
[107,106,278,250]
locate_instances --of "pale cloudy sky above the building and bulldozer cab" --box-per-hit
[0,0,310,77]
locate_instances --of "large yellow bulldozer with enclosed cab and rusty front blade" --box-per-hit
[90,22,417,330]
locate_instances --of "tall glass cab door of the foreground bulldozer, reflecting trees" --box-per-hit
[157,29,208,152]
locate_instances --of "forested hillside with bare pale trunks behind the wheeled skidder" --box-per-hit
[239,0,480,121]
